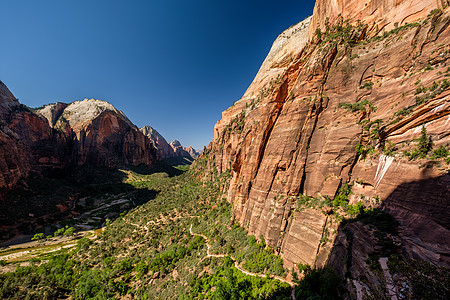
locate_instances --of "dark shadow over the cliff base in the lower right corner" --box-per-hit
[327,173,450,299]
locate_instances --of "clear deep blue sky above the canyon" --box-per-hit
[0,0,314,149]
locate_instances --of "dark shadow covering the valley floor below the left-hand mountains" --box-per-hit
[0,164,162,242]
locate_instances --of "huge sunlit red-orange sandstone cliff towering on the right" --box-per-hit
[201,1,450,294]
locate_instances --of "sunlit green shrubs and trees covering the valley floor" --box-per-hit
[0,168,300,299]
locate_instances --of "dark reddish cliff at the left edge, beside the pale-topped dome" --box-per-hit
[0,83,72,191]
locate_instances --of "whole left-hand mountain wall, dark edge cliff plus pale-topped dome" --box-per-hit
[0,88,157,191]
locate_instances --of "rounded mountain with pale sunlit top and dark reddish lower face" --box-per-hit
[55,99,156,167]
